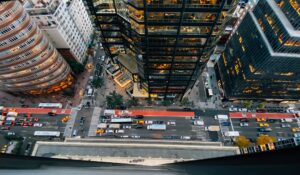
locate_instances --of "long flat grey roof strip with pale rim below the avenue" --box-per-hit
[33,141,239,164]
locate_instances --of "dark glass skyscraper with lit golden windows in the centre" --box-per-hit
[86,0,236,99]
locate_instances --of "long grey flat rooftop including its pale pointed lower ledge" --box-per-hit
[33,139,239,166]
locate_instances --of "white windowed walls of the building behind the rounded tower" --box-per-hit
[24,0,90,63]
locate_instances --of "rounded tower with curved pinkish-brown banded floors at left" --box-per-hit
[0,1,73,94]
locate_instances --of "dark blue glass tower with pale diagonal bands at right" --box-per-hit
[217,0,300,100]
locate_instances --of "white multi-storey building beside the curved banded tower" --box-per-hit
[24,0,93,63]
